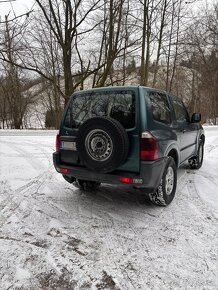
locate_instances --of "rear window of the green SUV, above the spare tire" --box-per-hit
[65,91,135,129]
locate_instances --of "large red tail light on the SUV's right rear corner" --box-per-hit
[140,131,159,160]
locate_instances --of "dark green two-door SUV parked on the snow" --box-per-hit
[53,86,205,206]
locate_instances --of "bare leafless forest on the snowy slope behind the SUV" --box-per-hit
[0,0,218,129]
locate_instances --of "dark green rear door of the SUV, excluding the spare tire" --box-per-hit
[60,88,139,172]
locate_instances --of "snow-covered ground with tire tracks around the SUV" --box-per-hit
[0,127,218,290]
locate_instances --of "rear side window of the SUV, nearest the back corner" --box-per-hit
[149,92,171,124]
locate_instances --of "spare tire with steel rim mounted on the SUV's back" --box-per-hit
[77,117,129,173]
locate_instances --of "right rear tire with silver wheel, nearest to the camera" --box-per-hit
[149,157,177,206]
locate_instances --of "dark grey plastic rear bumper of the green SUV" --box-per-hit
[53,152,167,192]
